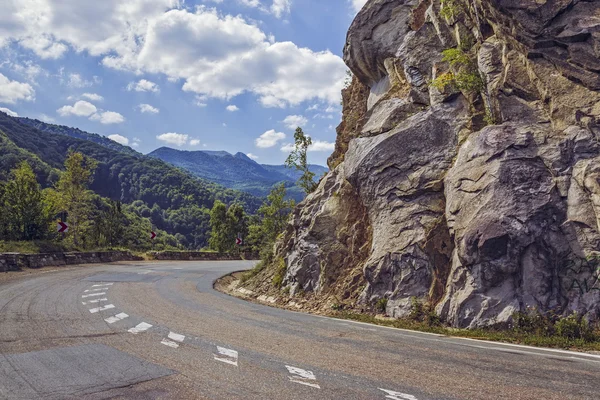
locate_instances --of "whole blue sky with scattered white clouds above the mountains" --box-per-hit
[0,0,365,165]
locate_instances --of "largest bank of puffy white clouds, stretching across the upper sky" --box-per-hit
[0,0,346,107]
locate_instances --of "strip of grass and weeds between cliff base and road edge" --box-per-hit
[330,311,600,351]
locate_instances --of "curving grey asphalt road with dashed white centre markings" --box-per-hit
[0,262,600,400]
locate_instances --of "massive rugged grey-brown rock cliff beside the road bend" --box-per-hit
[243,0,600,327]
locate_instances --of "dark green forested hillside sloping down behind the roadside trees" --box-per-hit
[0,112,262,248]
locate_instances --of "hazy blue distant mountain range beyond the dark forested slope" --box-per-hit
[148,147,328,201]
